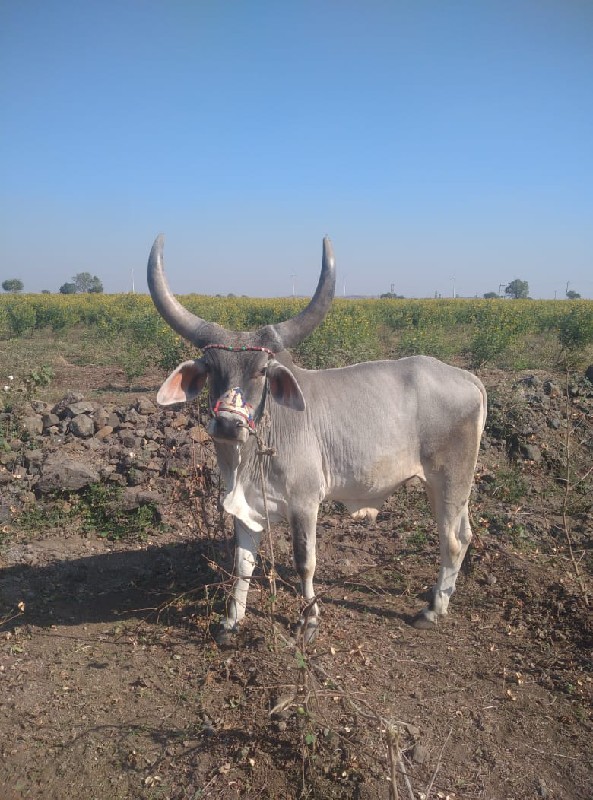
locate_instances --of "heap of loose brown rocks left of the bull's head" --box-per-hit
[0,393,213,532]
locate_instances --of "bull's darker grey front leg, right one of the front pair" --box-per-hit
[289,506,319,644]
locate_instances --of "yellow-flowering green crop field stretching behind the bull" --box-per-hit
[0,294,593,377]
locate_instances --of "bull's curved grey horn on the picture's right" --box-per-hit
[257,236,336,352]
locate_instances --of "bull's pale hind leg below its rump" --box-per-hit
[414,478,472,628]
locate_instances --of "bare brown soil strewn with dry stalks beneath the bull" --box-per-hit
[0,366,593,800]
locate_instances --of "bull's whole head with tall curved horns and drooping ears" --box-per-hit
[147,236,336,443]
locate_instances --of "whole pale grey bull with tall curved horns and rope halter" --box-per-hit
[148,237,486,640]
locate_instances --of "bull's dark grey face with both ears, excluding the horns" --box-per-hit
[157,345,305,443]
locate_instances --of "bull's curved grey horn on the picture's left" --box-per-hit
[146,234,231,347]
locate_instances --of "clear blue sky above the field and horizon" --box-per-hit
[0,0,593,297]
